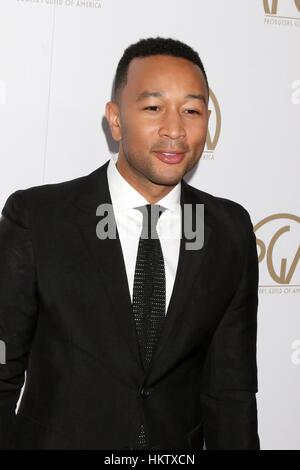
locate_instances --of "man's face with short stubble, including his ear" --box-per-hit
[106,55,209,196]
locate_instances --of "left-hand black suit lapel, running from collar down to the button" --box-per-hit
[73,161,142,368]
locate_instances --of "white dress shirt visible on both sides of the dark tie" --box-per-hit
[107,154,181,313]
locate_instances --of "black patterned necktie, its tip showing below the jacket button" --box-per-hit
[132,204,166,449]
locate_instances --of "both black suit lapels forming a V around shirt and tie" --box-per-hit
[69,161,211,380]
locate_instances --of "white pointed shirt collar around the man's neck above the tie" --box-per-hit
[107,154,181,212]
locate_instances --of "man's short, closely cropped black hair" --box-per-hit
[112,36,209,102]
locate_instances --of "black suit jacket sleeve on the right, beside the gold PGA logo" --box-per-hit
[201,212,260,450]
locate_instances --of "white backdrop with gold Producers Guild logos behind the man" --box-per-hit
[0,0,300,449]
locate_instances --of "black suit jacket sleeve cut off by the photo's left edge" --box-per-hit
[0,190,37,449]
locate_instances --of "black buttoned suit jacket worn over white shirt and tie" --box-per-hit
[0,161,260,450]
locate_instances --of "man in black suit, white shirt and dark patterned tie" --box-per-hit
[0,38,260,450]
